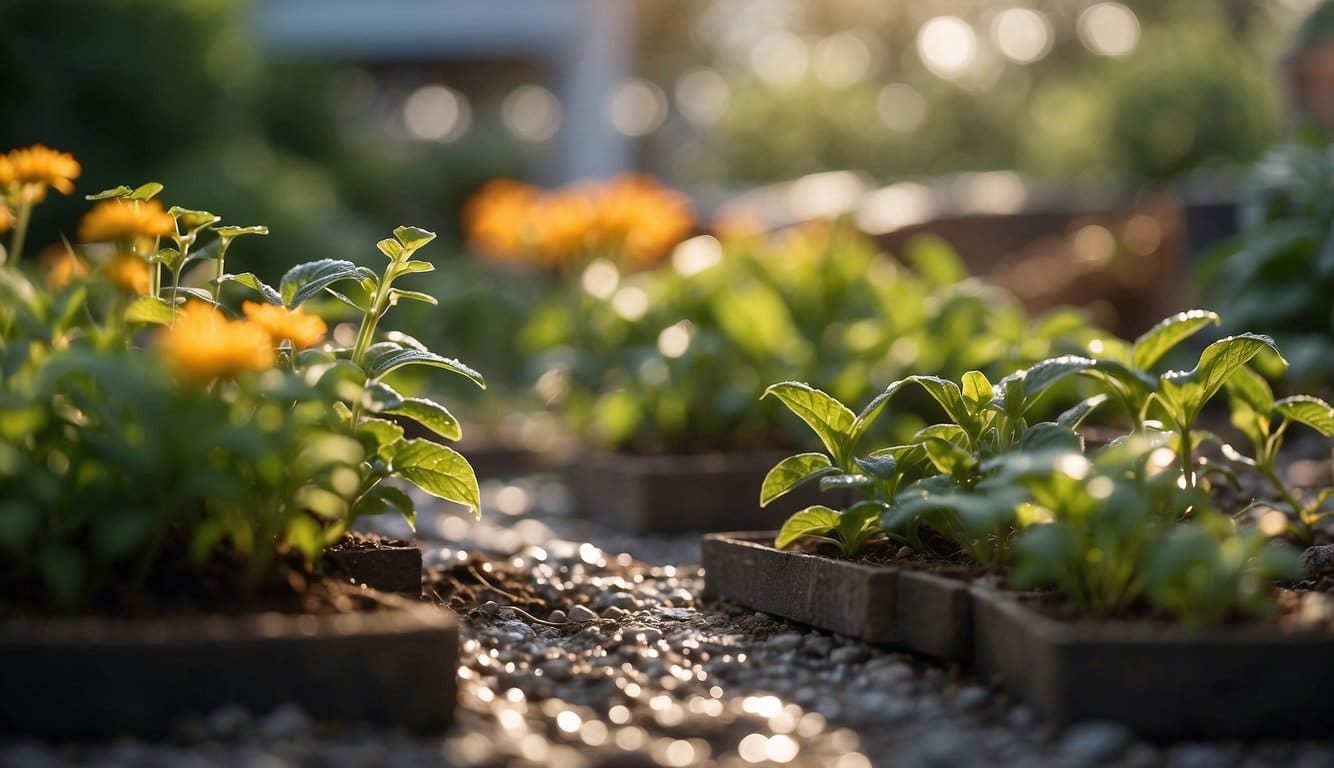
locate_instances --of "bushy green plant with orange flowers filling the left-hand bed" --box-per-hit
[0,156,484,607]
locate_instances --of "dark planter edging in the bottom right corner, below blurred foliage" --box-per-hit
[972,587,1334,739]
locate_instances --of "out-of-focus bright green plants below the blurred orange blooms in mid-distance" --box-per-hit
[504,213,1101,453]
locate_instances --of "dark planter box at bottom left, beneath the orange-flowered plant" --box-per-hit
[0,584,459,739]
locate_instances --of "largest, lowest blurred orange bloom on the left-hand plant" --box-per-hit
[156,301,273,381]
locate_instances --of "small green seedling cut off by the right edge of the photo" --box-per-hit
[1225,368,1334,547]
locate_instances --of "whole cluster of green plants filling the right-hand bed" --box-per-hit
[760,311,1334,625]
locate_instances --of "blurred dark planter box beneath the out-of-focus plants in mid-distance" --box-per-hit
[567,452,830,533]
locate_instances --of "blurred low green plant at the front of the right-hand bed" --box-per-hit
[998,436,1297,627]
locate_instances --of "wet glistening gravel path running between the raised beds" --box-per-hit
[0,477,1334,768]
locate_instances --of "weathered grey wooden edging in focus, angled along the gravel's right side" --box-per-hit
[703,532,972,664]
